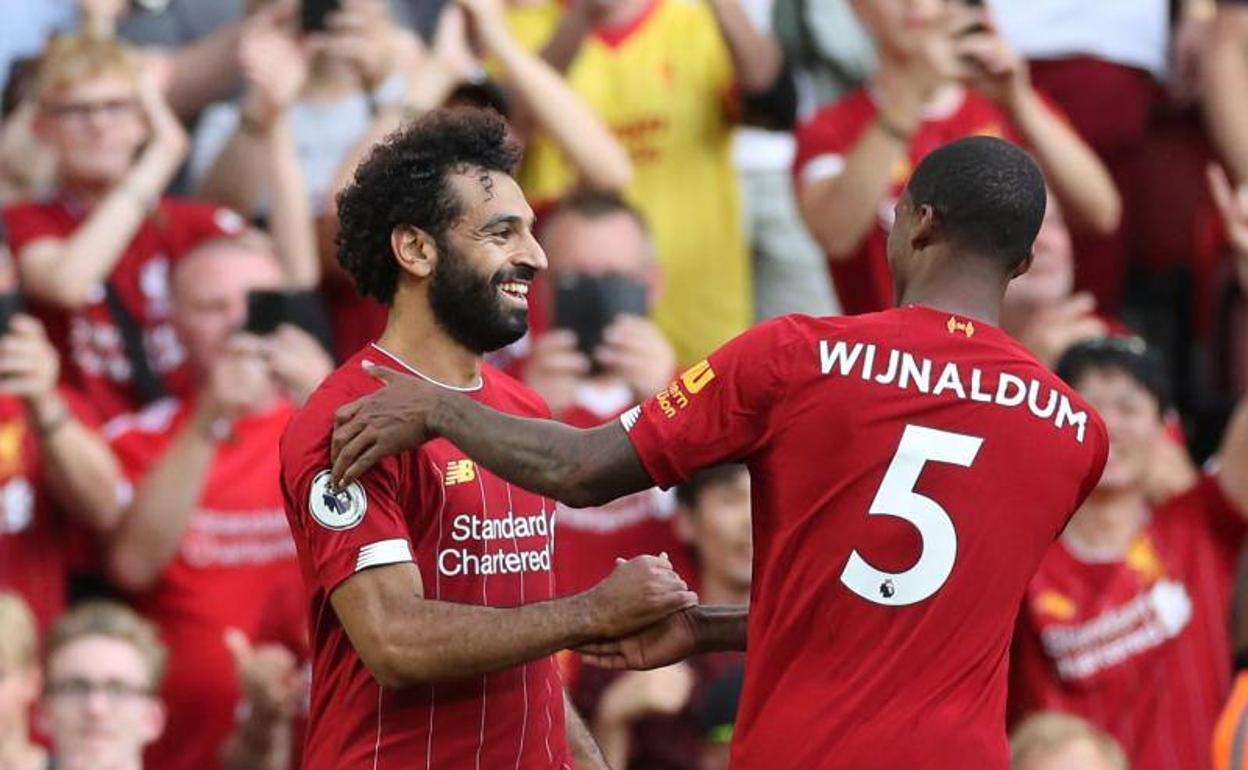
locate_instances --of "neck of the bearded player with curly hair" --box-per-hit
[377,290,482,388]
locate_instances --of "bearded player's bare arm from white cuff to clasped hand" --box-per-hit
[329,557,698,688]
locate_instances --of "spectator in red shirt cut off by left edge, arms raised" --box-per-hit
[0,239,121,629]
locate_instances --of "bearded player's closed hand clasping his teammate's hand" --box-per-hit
[583,554,698,639]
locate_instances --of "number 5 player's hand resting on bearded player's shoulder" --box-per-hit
[329,362,439,487]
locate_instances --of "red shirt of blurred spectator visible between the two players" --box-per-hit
[555,388,698,595]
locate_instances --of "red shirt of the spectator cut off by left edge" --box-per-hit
[0,389,94,630]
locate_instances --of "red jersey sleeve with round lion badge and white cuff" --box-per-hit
[281,389,413,594]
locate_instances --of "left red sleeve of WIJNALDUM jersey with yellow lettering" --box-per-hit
[620,318,795,489]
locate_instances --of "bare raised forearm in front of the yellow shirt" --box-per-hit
[490,27,633,191]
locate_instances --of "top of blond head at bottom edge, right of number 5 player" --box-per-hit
[1010,711,1129,770]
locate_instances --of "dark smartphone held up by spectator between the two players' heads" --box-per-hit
[554,275,648,371]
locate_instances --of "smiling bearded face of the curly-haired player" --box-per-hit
[428,170,547,353]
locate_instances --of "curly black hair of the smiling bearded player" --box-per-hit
[337,107,520,305]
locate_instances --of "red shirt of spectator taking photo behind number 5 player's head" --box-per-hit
[794,89,1013,314]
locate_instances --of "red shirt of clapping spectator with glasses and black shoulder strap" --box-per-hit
[4,197,245,419]
